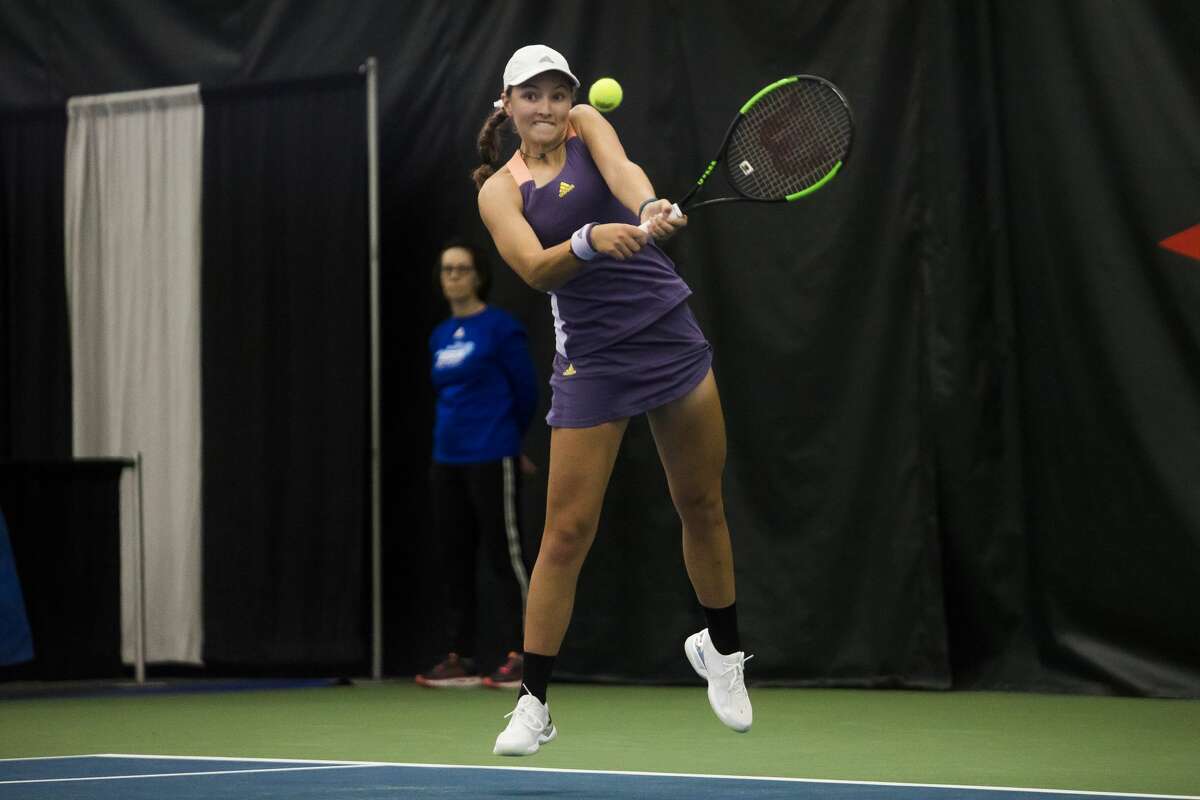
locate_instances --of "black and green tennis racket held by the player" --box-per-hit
[638,76,854,230]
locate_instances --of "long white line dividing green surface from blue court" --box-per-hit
[75,753,1200,800]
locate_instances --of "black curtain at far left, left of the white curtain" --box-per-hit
[0,106,71,458]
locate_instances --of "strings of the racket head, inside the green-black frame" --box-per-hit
[726,79,853,200]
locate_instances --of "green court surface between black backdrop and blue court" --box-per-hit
[0,681,1200,795]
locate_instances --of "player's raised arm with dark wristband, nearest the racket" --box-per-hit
[570,104,688,239]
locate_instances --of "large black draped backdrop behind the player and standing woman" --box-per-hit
[0,0,1200,694]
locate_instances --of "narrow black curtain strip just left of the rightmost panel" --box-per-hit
[911,1,1041,688]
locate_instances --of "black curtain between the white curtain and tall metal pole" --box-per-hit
[202,74,370,670]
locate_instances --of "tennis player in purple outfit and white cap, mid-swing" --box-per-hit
[474,44,752,756]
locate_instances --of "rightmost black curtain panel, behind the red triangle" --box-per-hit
[994,2,1200,696]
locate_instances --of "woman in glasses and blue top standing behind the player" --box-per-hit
[416,237,538,688]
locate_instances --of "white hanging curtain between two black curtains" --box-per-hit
[65,85,204,663]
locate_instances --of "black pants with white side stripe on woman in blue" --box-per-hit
[430,458,529,655]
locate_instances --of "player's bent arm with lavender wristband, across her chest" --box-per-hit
[479,170,647,291]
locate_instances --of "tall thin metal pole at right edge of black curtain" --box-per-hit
[365,56,383,680]
